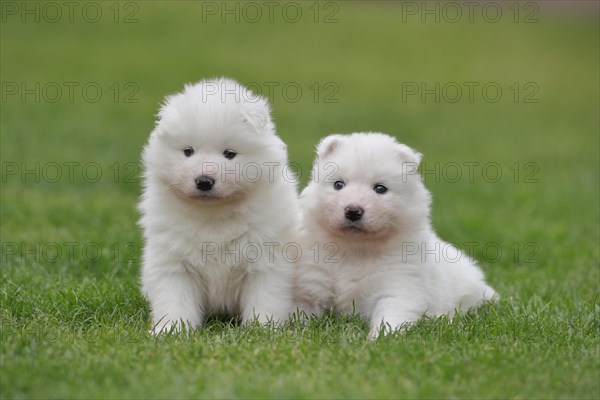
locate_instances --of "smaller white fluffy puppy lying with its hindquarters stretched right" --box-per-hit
[295,133,496,338]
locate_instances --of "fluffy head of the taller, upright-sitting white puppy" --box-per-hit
[143,78,287,204]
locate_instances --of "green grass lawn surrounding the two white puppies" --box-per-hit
[0,2,600,398]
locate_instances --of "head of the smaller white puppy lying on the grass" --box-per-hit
[302,133,431,241]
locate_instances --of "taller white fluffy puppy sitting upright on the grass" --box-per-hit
[139,78,299,334]
